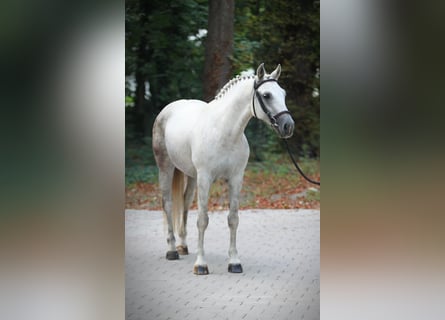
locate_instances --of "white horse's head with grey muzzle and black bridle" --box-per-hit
[252,63,295,139]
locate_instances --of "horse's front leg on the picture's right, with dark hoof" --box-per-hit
[227,175,243,273]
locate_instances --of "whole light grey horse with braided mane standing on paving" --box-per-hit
[153,64,294,275]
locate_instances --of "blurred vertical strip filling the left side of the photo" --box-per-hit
[0,0,125,320]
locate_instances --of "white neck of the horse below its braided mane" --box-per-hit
[212,79,254,139]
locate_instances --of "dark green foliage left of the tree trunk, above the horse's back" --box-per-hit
[125,0,207,141]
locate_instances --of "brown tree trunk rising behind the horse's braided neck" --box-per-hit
[203,0,234,101]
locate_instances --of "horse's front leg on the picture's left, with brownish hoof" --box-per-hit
[193,172,212,275]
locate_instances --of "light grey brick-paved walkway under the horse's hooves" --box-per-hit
[125,210,320,320]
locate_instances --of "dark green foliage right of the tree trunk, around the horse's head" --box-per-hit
[234,0,320,160]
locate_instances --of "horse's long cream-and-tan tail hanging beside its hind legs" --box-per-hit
[172,168,186,234]
